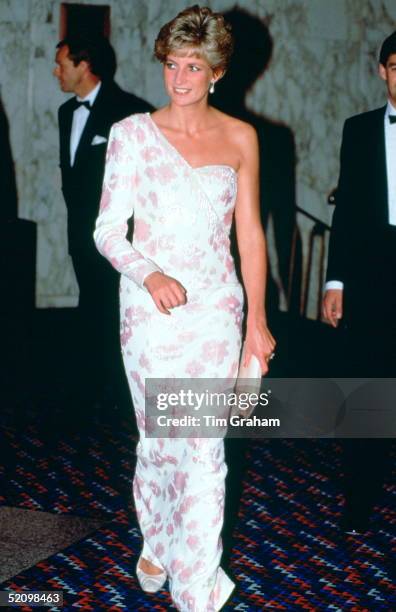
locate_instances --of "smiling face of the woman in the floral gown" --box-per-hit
[164,53,215,106]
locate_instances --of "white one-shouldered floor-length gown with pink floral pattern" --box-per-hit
[95,114,243,612]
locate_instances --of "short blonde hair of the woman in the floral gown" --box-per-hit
[154,4,234,70]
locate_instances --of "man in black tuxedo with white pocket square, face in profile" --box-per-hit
[54,36,152,416]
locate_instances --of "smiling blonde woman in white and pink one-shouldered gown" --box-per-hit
[95,6,275,612]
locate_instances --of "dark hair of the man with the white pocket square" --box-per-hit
[56,35,117,81]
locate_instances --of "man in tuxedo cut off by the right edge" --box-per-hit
[323,32,396,533]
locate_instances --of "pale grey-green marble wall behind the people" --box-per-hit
[0,0,396,316]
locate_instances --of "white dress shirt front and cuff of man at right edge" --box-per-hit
[325,100,396,291]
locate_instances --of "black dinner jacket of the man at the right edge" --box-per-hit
[326,106,389,316]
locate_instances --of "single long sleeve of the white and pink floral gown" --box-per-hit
[94,122,162,289]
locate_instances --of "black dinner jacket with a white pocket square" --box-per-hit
[58,82,153,254]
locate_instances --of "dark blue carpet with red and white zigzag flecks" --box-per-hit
[0,408,396,612]
